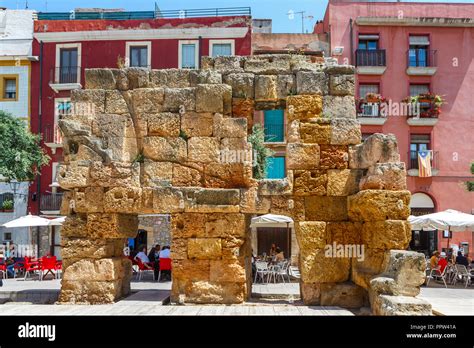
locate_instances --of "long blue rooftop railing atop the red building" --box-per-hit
[38,7,252,21]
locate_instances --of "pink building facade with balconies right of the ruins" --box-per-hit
[315,0,474,257]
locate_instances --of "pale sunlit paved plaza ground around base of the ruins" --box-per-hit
[0,279,474,316]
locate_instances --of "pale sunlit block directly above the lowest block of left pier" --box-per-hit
[63,257,124,282]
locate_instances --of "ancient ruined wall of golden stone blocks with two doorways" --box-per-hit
[59,55,429,314]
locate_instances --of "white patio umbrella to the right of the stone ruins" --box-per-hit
[408,209,474,247]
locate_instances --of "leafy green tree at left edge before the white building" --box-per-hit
[0,111,50,182]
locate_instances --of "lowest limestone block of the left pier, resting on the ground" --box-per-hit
[58,279,124,304]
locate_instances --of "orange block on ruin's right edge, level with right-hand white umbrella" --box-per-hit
[362,220,411,250]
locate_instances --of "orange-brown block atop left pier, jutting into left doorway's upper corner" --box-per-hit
[86,213,138,239]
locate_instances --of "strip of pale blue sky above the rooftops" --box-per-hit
[0,0,474,33]
